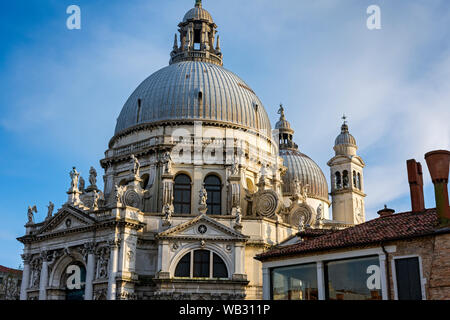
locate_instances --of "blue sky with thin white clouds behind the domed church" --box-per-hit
[0,0,450,267]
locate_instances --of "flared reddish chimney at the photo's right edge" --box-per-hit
[425,150,450,226]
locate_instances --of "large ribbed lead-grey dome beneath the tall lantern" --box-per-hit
[115,61,271,137]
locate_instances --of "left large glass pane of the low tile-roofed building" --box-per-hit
[271,263,319,300]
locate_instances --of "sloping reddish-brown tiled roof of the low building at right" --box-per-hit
[255,208,450,260]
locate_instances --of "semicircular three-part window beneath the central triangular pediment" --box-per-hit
[175,250,228,279]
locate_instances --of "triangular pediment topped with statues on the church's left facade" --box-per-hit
[37,205,96,235]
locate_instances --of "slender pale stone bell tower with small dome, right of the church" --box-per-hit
[327,115,366,225]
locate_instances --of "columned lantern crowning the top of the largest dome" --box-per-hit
[169,0,223,66]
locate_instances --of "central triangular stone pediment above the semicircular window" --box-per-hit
[156,214,249,241]
